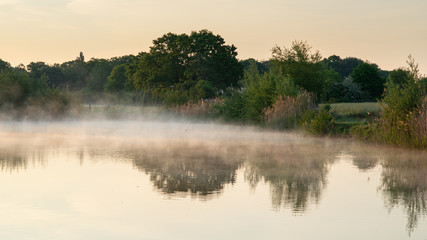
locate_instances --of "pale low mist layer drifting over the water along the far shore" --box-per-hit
[0,120,314,145]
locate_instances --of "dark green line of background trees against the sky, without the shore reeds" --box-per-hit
[0,30,425,105]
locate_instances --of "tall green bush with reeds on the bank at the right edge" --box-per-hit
[356,56,427,148]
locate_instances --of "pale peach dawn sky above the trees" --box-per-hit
[0,0,427,74]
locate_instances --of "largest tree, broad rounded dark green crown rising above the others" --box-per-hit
[134,30,243,100]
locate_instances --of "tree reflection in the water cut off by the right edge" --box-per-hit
[381,152,427,234]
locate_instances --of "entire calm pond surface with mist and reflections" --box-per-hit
[0,121,427,239]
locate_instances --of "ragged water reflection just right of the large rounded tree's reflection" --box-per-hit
[245,144,334,213]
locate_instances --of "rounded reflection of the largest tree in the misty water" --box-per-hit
[134,144,244,199]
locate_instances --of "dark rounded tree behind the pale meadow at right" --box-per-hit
[350,63,385,100]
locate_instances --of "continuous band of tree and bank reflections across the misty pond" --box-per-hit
[0,125,427,236]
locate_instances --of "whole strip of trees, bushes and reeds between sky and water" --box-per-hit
[0,30,427,149]
